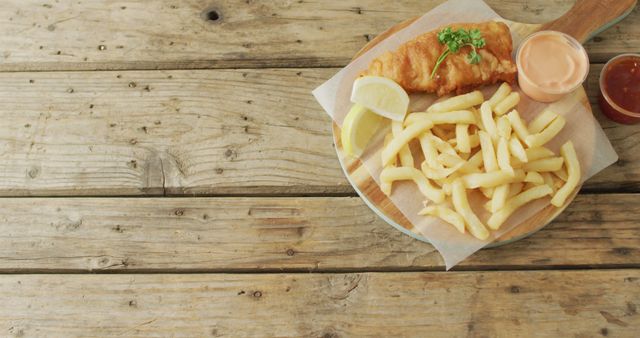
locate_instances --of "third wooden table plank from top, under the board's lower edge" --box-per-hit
[0,194,640,272]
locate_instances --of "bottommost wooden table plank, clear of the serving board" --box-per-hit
[0,270,640,337]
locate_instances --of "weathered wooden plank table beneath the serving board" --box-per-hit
[0,0,640,337]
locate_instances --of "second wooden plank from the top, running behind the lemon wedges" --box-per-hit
[0,65,640,196]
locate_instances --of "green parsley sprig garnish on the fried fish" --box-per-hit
[431,27,485,79]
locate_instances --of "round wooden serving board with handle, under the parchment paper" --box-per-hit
[333,0,637,247]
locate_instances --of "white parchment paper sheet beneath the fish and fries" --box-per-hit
[313,0,618,269]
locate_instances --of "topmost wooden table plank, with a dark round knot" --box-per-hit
[0,0,640,71]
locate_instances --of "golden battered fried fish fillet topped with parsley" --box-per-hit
[362,21,517,96]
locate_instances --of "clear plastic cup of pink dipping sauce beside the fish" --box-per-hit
[516,31,589,102]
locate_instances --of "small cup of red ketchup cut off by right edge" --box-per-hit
[599,54,640,124]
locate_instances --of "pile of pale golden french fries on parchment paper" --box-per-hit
[380,83,580,240]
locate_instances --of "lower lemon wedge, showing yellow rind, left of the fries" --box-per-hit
[340,103,383,157]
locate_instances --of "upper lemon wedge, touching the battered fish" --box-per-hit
[351,76,409,121]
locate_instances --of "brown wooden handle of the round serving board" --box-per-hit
[540,0,638,43]
